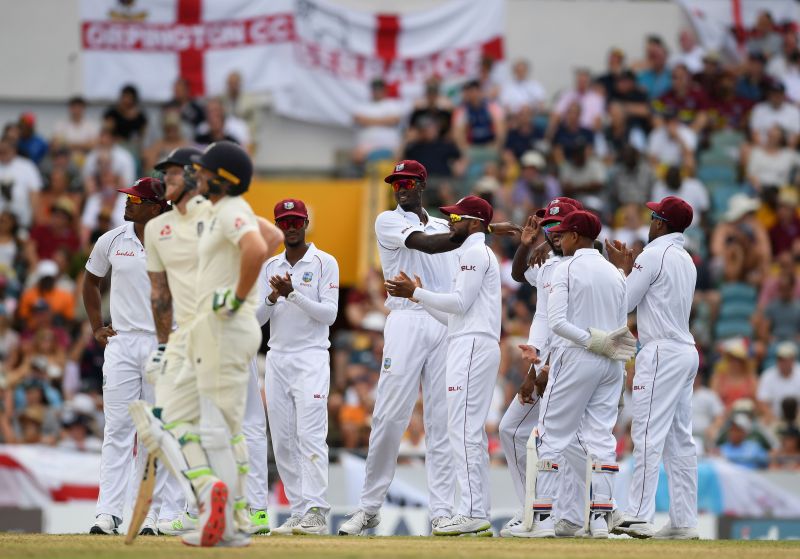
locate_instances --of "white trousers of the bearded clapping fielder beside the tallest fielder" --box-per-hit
[447,336,500,519]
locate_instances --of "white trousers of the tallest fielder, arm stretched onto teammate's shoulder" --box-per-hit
[359,310,455,518]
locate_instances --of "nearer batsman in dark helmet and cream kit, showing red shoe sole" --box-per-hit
[131,141,268,547]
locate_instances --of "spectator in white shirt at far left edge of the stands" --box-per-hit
[0,138,42,229]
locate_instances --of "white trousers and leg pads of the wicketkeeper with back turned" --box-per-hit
[536,347,625,524]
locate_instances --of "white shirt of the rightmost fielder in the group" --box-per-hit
[626,233,697,345]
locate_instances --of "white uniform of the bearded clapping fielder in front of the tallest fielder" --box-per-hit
[414,233,502,519]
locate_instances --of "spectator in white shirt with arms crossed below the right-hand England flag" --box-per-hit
[353,79,406,163]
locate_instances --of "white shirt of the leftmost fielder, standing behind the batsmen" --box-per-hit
[86,222,155,333]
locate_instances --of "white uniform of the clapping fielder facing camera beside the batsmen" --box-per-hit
[257,244,339,515]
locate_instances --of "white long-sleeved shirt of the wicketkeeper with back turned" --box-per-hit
[547,248,627,347]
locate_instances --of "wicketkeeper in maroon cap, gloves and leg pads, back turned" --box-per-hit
[532,210,636,538]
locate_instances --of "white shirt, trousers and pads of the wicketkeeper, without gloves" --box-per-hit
[536,249,627,521]
